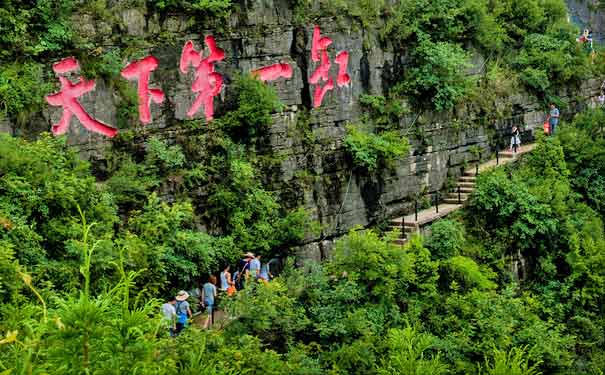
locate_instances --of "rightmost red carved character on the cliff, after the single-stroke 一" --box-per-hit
[309,26,351,108]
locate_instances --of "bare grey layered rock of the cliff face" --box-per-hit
[0,0,600,258]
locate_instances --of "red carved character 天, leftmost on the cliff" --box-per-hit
[46,57,118,137]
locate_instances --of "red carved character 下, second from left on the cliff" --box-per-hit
[122,56,164,124]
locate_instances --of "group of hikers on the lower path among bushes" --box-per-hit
[162,252,278,337]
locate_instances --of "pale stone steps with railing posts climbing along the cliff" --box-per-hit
[390,144,534,245]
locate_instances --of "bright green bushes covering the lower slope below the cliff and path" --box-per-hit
[0,110,605,375]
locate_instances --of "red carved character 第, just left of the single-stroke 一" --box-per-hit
[180,35,225,121]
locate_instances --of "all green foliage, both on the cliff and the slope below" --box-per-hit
[0,0,605,375]
